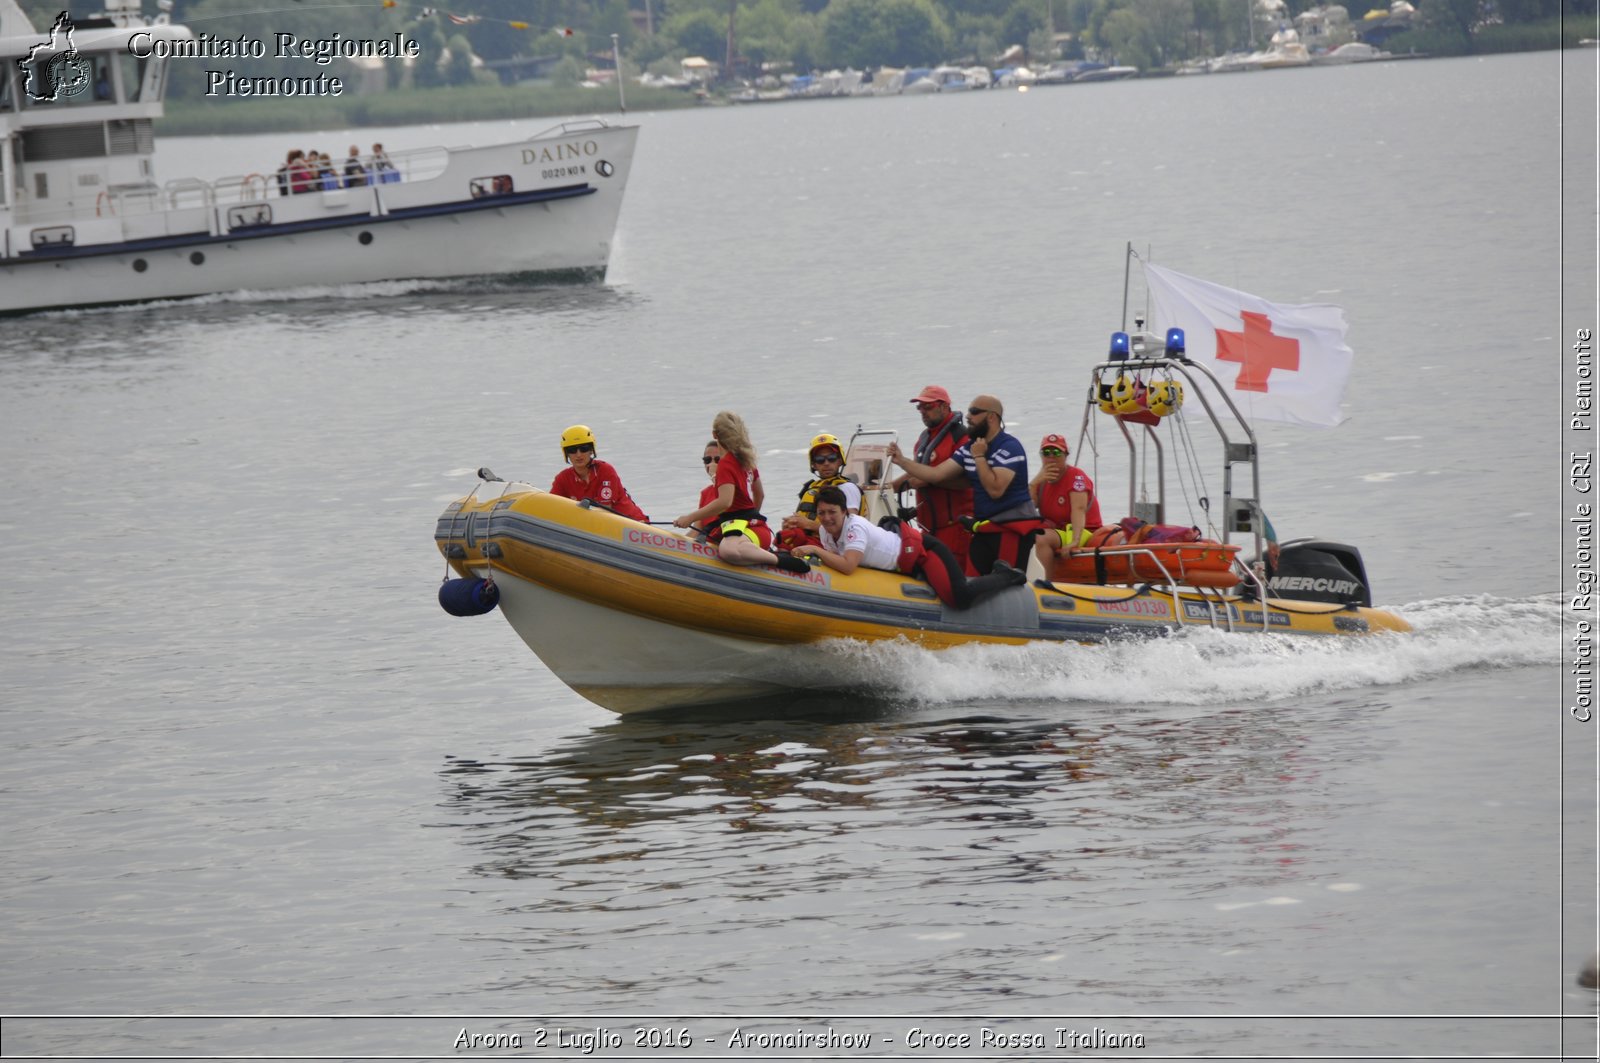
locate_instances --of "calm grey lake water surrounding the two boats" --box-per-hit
[0,51,1597,1058]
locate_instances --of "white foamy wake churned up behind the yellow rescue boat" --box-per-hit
[812,594,1562,706]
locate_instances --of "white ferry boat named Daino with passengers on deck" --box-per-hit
[0,0,638,314]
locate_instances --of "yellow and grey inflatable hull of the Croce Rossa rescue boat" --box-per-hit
[435,490,1406,712]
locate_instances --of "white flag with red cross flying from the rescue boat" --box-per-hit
[1144,263,1355,427]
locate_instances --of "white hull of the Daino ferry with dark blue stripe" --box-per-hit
[0,126,638,314]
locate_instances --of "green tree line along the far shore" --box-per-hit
[22,0,1597,99]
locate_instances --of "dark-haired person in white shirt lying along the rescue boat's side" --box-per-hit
[795,487,1027,608]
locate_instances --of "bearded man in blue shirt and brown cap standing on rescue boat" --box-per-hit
[888,395,1045,575]
